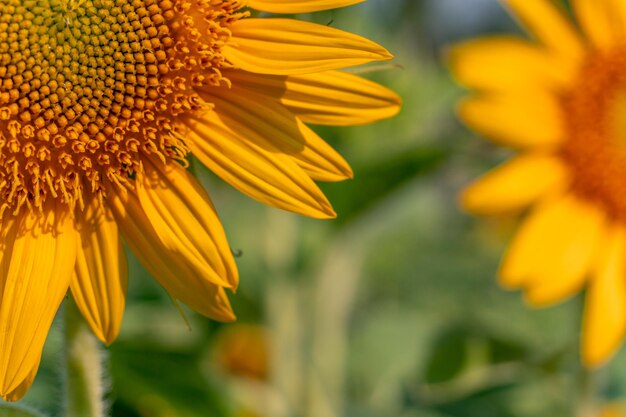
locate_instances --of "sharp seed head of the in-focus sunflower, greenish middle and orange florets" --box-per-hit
[0,0,243,217]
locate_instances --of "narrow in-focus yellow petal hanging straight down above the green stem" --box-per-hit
[70,198,128,344]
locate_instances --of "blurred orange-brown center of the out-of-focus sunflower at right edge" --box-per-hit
[563,51,626,220]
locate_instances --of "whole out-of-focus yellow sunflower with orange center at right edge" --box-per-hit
[451,0,626,366]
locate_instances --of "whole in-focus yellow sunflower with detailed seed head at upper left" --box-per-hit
[0,0,399,400]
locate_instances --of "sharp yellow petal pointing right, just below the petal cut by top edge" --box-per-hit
[223,19,392,75]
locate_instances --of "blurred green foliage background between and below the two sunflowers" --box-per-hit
[9,0,626,417]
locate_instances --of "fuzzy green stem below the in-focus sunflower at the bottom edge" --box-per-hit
[65,297,105,417]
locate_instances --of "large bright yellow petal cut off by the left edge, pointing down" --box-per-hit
[0,209,77,398]
